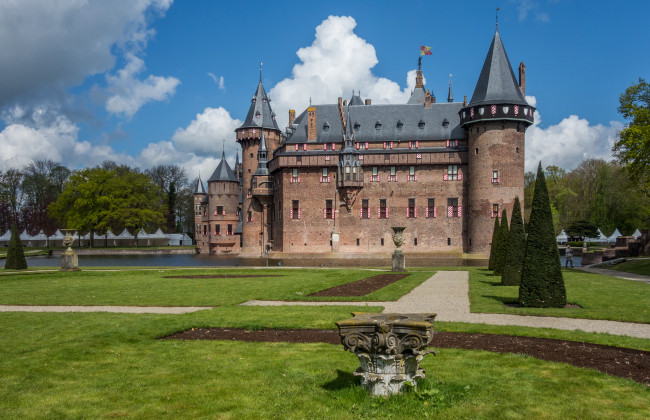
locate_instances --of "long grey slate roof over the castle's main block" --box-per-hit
[285,102,465,144]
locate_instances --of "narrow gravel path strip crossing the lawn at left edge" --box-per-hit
[0,305,212,314]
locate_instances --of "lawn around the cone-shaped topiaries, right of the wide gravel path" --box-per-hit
[469,268,650,323]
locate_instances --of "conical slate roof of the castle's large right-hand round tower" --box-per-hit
[468,32,528,106]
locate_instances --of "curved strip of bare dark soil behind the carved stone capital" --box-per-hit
[163,328,650,385]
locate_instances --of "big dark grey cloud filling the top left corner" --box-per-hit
[0,0,171,107]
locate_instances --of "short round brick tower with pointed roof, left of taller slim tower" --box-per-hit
[202,152,240,254]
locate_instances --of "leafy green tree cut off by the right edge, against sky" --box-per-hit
[612,78,650,196]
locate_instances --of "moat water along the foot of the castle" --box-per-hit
[27,254,581,268]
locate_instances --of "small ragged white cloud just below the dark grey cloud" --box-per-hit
[106,53,180,117]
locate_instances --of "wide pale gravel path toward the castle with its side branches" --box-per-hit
[243,271,650,339]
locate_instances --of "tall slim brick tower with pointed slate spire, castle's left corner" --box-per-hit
[235,72,281,255]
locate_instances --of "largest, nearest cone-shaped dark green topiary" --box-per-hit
[519,162,566,308]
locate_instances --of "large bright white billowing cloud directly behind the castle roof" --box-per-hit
[269,16,415,127]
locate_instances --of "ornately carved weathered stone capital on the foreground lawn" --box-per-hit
[336,312,436,396]
